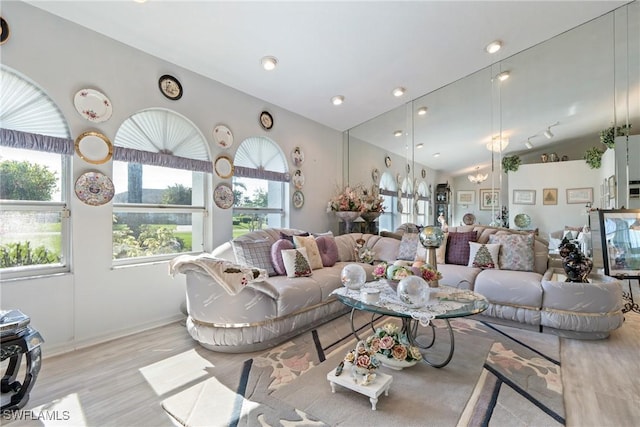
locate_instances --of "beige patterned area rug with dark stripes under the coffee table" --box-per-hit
[162,313,564,427]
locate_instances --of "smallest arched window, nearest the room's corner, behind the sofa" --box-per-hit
[233,137,289,237]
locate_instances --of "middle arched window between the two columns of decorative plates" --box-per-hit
[113,108,212,264]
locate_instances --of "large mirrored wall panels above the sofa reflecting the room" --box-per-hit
[345,1,640,232]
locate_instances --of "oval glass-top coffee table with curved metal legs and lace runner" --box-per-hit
[331,280,489,368]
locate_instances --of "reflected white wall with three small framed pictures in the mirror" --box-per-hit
[509,160,601,238]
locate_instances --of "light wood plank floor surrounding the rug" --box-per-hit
[5,304,640,427]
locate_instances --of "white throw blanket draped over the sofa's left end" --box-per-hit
[169,253,269,295]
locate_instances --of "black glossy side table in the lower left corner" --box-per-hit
[0,310,44,411]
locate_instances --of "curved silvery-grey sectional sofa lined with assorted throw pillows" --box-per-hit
[170,226,623,352]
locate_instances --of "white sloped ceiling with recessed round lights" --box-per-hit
[22,0,628,176]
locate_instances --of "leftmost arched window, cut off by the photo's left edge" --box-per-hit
[0,66,73,278]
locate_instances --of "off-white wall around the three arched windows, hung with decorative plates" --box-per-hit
[0,2,342,356]
